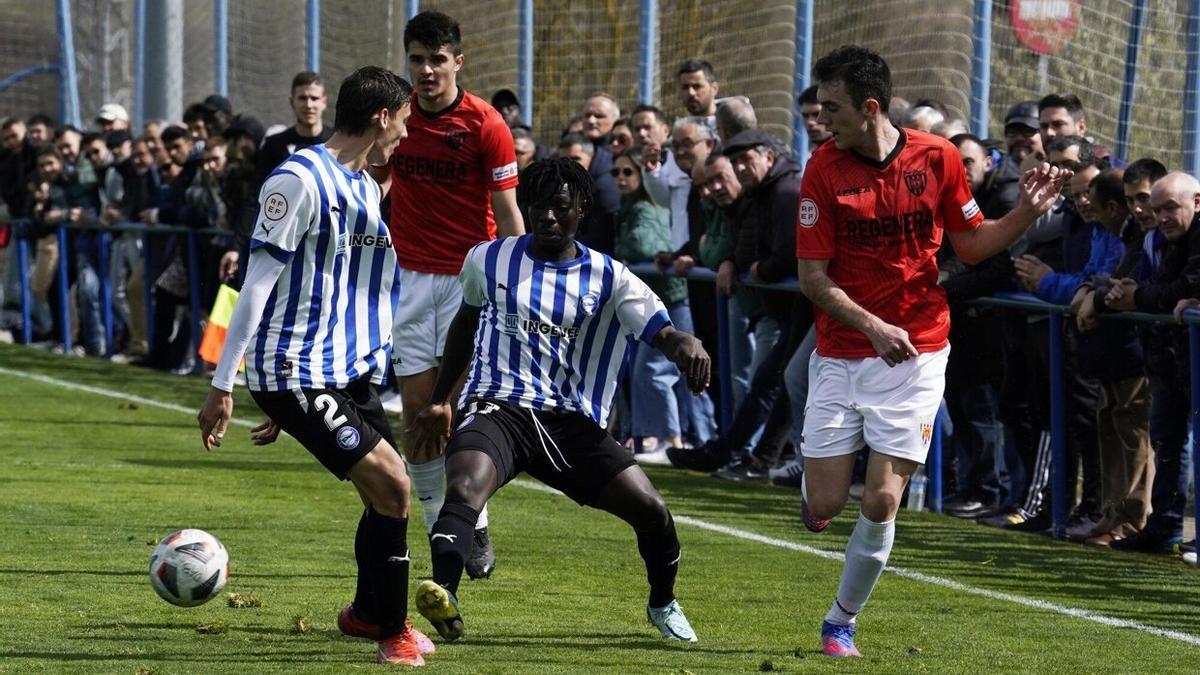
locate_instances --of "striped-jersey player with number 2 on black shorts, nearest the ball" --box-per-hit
[198,66,433,665]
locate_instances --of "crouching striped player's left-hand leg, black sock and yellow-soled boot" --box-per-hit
[416,449,497,640]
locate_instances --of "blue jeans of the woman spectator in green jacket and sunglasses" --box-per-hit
[630,300,716,444]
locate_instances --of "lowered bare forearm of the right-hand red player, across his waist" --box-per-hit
[797,258,917,368]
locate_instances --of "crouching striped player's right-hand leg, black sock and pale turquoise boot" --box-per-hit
[592,465,696,643]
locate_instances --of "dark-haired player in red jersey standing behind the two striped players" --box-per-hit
[374,12,524,579]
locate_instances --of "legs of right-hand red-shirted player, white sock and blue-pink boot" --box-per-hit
[805,450,917,656]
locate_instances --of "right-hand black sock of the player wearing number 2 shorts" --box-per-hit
[364,508,408,638]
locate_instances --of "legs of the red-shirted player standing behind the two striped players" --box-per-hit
[400,368,496,579]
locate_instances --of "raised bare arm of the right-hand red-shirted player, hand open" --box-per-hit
[948,163,1073,264]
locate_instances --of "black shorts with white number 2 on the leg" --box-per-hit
[250,377,396,480]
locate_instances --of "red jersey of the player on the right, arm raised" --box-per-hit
[796,129,984,359]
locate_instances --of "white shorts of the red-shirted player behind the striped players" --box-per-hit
[391,268,462,377]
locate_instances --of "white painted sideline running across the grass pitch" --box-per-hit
[7,366,1200,646]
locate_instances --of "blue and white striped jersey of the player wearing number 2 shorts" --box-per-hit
[246,145,400,392]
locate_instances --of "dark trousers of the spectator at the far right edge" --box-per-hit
[1146,374,1194,537]
